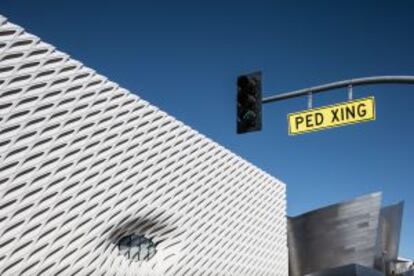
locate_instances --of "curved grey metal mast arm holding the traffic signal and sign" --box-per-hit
[262,76,414,103]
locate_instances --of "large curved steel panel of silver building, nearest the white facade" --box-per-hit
[288,193,381,276]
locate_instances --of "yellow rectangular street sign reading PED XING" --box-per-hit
[288,97,375,135]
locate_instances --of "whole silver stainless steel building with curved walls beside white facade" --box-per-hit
[288,193,403,276]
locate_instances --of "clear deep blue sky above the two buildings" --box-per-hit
[0,0,414,258]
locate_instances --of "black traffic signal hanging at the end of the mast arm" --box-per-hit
[237,72,262,133]
